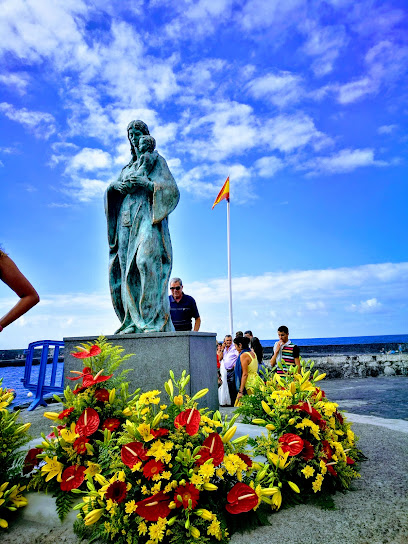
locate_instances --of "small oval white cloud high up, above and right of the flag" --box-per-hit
[248,72,304,107]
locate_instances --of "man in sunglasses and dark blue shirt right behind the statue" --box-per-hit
[169,278,201,331]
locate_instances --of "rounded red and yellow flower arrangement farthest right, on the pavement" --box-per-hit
[237,360,362,510]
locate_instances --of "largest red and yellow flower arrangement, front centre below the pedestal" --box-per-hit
[75,371,275,544]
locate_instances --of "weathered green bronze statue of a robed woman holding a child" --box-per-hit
[105,121,180,334]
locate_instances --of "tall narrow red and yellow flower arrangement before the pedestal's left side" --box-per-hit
[25,337,136,519]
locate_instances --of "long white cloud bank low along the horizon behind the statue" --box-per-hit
[0,262,408,349]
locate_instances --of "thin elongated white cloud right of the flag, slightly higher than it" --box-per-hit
[300,149,387,174]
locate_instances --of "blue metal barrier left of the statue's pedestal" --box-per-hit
[21,340,64,411]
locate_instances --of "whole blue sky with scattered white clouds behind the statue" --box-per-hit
[0,0,408,348]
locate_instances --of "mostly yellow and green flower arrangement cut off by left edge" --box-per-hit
[0,379,31,529]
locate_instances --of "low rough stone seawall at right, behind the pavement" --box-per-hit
[304,353,408,378]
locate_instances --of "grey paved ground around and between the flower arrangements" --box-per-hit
[0,377,408,544]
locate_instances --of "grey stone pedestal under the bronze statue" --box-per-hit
[64,331,218,410]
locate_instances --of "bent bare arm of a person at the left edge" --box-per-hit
[0,255,40,328]
